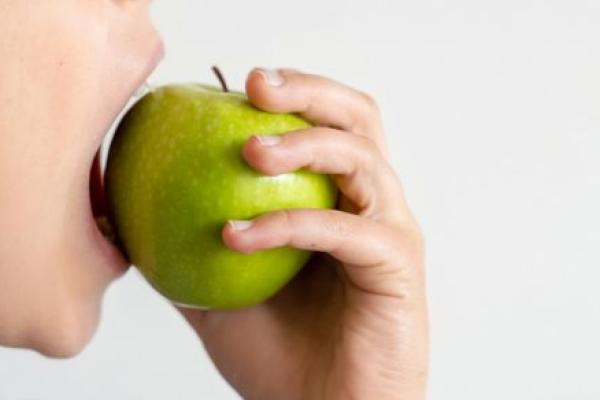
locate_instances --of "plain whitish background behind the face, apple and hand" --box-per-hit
[0,0,600,400]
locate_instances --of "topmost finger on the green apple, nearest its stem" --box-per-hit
[246,68,386,155]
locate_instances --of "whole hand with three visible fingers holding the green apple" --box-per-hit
[182,70,427,400]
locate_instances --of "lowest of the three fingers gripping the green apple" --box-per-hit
[222,209,421,298]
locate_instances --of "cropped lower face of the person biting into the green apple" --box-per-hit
[0,0,162,356]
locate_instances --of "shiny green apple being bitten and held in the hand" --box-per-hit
[105,84,337,309]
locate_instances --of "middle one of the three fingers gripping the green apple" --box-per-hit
[243,127,407,220]
